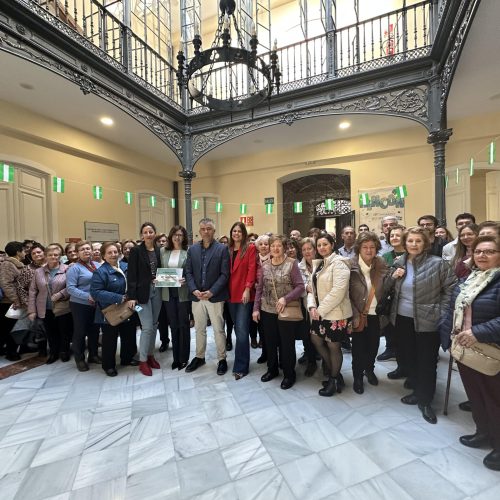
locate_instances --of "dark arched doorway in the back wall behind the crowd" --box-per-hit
[282,171,354,241]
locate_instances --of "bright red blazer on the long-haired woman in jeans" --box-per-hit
[229,244,257,304]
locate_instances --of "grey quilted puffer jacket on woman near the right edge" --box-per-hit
[384,253,457,332]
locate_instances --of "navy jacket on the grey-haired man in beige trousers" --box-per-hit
[186,240,229,302]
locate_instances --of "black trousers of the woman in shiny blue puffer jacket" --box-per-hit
[101,320,137,370]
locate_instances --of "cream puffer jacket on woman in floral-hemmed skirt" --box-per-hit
[307,254,352,321]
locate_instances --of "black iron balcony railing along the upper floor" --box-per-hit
[26,0,434,113]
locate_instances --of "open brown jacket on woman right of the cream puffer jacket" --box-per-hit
[349,256,388,323]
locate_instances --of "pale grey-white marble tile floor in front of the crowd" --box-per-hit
[0,328,500,500]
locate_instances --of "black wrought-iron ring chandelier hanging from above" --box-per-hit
[177,0,281,112]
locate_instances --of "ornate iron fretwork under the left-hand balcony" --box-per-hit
[0,24,183,162]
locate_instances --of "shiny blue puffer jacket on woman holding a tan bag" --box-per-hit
[90,262,127,324]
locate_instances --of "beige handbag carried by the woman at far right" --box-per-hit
[450,335,500,376]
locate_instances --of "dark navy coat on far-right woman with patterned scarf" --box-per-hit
[440,272,500,350]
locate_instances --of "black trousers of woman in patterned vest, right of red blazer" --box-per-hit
[260,311,298,379]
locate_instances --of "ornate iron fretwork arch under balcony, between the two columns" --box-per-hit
[193,85,429,162]
